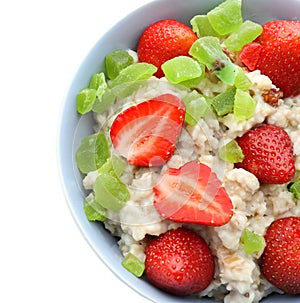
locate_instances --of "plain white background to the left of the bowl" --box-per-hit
[0,0,150,303]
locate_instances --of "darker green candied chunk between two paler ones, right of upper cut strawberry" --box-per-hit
[211,87,236,117]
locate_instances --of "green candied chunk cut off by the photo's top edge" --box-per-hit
[207,0,243,35]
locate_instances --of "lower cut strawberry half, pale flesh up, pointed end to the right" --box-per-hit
[154,161,233,226]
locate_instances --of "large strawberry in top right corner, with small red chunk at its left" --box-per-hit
[240,20,300,97]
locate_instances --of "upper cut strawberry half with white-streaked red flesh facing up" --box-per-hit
[110,94,185,166]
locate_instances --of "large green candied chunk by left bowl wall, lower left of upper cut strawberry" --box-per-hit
[76,133,110,174]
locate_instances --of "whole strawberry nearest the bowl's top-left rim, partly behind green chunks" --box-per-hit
[137,19,197,78]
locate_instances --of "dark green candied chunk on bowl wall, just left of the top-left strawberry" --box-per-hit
[105,49,134,80]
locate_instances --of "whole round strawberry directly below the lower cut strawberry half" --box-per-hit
[145,228,214,296]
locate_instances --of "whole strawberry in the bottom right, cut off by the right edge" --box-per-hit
[261,217,300,294]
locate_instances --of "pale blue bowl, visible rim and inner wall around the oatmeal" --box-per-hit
[58,0,300,303]
